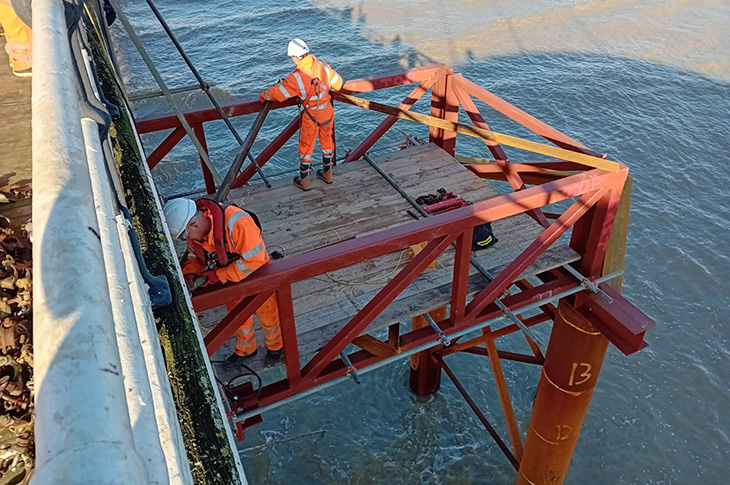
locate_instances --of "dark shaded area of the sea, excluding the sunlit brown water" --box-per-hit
[111,2,730,485]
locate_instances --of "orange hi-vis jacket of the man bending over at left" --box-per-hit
[183,205,271,283]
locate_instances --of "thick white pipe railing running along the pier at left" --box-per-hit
[31,0,192,484]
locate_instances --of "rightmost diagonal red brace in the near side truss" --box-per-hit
[466,188,607,316]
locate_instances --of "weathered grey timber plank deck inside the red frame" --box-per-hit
[183,143,580,381]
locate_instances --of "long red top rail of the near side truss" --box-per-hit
[193,169,625,311]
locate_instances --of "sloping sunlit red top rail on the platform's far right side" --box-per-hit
[454,74,602,157]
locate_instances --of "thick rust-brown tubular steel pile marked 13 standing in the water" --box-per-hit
[515,300,608,485]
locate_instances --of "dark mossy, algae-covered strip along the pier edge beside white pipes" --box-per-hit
[82,9,245,484]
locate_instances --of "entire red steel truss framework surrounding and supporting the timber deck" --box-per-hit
[137,65,651,464]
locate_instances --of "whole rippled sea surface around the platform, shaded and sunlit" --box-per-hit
[109,0,730,484]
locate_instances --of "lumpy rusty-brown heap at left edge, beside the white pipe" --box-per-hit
[0,176,35,485]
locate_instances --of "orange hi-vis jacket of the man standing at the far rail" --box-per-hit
[263,54,342,110]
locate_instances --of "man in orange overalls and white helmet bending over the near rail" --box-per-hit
[163,198,283,367]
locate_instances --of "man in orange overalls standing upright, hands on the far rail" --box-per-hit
[259,39,342,190]
